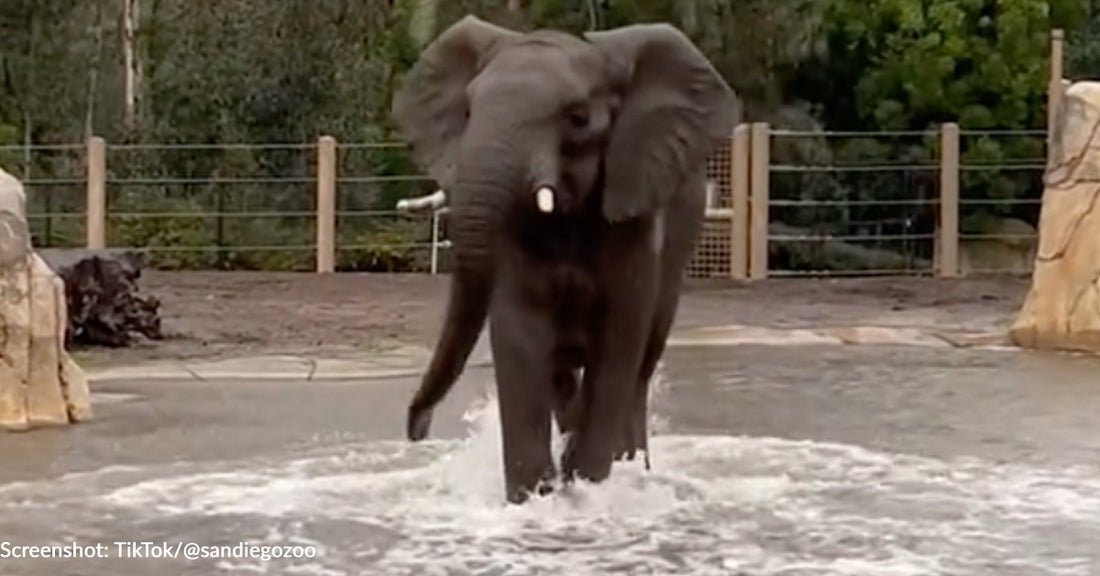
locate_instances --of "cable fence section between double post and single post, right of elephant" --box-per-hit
[767,130,941,276]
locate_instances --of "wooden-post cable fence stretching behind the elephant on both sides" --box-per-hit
[0,123,1046,278]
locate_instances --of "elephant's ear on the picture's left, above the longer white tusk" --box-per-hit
[392,15,519,189]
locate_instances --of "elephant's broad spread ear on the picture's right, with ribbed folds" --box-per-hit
[585,24,736,222]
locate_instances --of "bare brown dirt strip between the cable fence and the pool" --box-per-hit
[77,270,1030,364]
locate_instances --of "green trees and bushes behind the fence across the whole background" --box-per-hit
[0,0,1086,269]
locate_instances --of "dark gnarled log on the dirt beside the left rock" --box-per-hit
[39,248,164,347]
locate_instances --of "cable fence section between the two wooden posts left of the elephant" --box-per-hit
[103,144,317,270]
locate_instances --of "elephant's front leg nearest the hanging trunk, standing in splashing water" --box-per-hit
[490,280,556,503]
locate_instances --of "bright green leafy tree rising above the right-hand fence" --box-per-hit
[827,0,1049,130]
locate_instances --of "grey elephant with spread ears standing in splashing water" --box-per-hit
[391,15,737,503]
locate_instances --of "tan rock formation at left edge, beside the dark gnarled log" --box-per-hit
[0,164,91,430]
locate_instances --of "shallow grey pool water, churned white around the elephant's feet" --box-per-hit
[0,345,1100,576]
